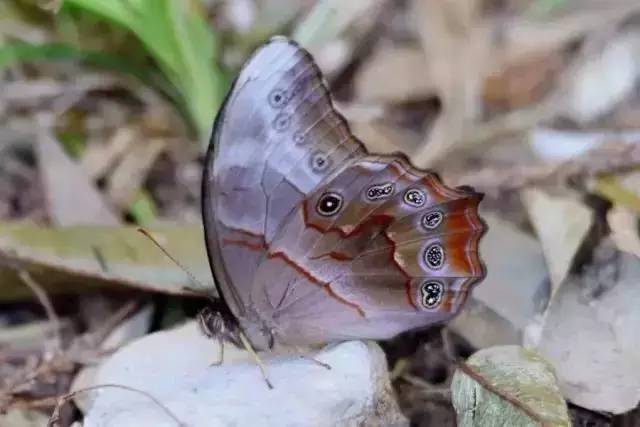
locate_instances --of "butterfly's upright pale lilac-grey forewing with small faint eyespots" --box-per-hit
[202,38,364,318]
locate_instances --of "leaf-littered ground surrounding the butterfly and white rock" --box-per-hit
[0,0,640,426]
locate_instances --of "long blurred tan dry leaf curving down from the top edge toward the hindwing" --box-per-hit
[412,0,491,167]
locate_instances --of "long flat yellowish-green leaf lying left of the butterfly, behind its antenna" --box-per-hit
[0,223,215,301]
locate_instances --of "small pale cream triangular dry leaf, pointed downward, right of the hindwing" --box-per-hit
[522,188,592,295]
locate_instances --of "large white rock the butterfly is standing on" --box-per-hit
[84,322,407,427]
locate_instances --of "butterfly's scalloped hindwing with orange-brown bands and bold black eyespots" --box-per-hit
[251,156,485,344]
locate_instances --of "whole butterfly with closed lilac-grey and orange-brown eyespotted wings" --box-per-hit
[202,36,486,356]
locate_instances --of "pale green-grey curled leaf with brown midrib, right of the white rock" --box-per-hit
[451,346,571,427]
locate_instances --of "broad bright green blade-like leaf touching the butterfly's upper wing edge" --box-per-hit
[65,0,227,143]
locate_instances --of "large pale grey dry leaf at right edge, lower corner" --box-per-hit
[537,253,640,414]
